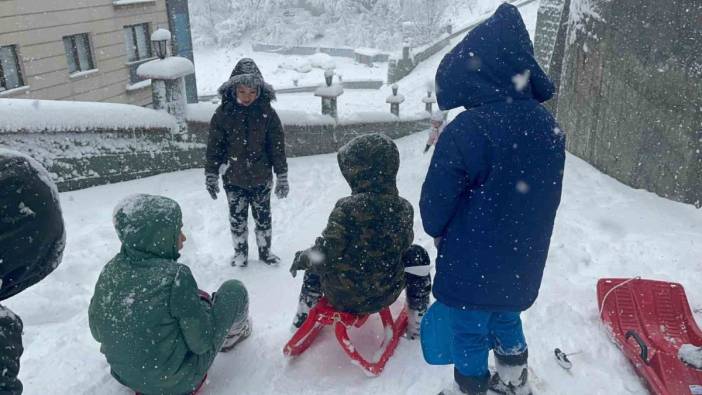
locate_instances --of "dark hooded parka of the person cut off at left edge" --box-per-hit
[0,149,66,395]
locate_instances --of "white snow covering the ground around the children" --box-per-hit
[7,4,702,395]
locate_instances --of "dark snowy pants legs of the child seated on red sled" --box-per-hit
[300,244,431,312]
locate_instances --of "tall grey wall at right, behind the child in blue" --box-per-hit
[537,0,702,206]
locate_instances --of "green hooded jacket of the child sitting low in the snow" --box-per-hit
[89,195,221,394]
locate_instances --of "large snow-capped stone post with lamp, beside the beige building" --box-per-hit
[137,29,195,134]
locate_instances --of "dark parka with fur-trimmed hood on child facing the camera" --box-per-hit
[205,58,288,188]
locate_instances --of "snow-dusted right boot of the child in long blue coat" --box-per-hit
[490,350,531,395]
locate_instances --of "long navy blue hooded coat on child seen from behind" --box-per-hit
[419,4,565,311]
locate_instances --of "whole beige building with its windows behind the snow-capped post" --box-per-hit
[0,0,196,106]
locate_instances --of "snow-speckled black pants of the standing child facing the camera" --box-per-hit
[224,183,272,258]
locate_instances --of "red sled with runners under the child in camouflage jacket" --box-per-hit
[283,297,407,376]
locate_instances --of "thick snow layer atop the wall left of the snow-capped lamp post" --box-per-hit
[0,99,176,133]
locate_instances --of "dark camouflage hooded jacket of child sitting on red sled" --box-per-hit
[300,134,414,314]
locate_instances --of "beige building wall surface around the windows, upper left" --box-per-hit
[0,0,168,106]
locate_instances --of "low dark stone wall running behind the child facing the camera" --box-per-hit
[0,120,429,191]
